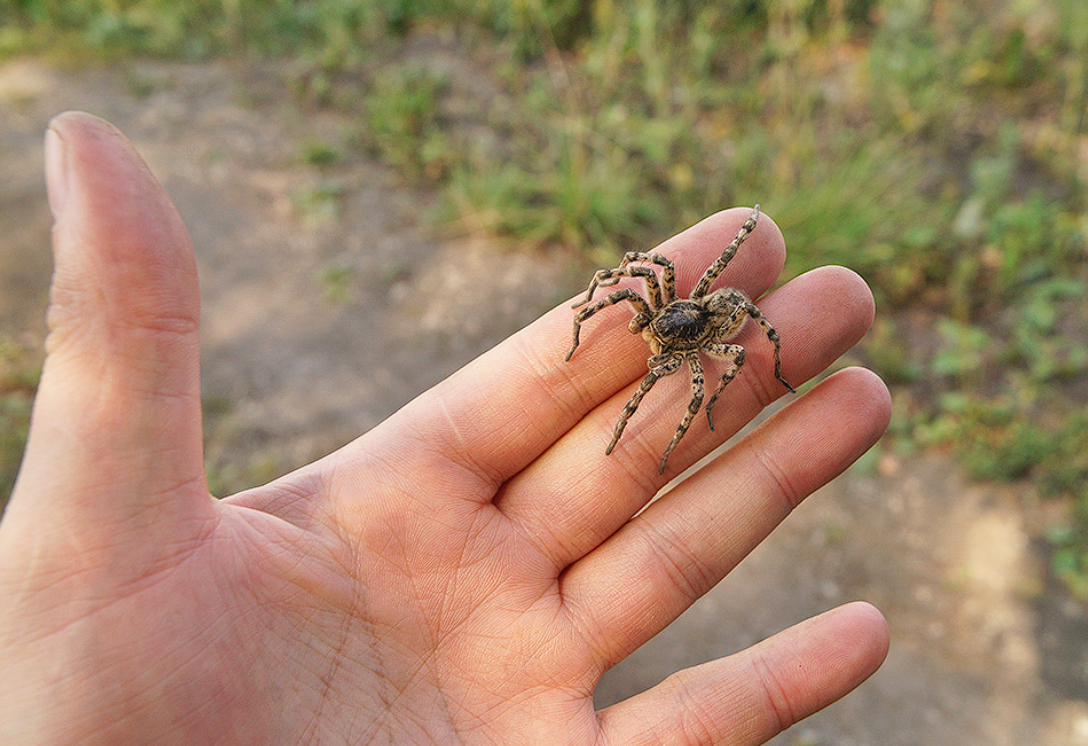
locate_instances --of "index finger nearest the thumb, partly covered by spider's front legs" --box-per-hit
[369,208,786,488]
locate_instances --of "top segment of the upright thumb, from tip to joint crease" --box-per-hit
[46,111,199,344]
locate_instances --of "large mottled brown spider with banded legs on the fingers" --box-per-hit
[567,204,796,474]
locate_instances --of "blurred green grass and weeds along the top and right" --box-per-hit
[6,0,1088,596]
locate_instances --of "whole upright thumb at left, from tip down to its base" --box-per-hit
[9,112,211,532]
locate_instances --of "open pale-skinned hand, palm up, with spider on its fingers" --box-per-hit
[0,113,889,746]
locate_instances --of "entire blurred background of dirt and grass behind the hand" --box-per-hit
[0,0,1088,746]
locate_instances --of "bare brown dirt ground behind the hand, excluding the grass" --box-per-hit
[0,60,1088,746]
